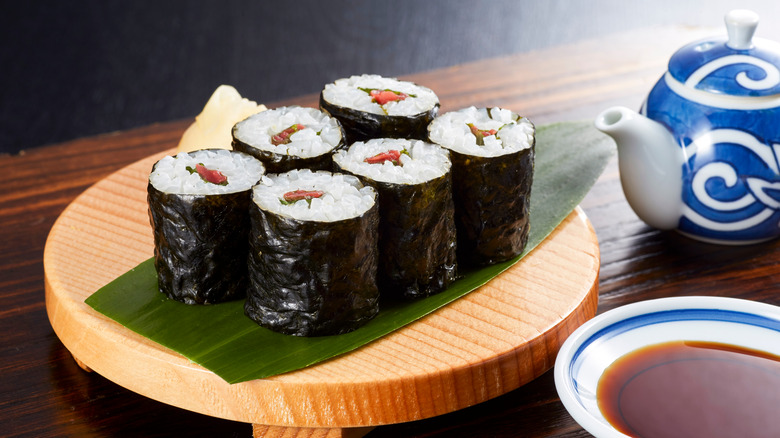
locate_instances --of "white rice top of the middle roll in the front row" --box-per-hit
[333,138,451,184]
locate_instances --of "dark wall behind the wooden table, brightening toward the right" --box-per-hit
[0,0,780,153]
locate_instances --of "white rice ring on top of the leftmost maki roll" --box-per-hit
[149,149,265,195]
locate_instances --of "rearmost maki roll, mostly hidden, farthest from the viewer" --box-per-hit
[320,75,439,144]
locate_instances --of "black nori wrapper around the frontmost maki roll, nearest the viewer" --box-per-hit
[244,190,379,336]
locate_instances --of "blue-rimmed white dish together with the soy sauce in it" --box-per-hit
[554,297,780,438]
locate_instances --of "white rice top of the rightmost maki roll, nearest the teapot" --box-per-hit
[428,106,535,157]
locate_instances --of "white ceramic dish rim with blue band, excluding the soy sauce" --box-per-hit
[554,297,780,438]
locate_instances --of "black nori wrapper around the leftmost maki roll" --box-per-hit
[147,176,251,304]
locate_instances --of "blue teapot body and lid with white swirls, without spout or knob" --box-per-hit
[641,10,780,243]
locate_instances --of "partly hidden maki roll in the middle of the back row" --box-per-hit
[232,106,345,173]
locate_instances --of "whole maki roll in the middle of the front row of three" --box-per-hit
[333,139,457,299]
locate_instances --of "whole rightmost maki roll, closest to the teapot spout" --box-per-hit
[429,107,535,265]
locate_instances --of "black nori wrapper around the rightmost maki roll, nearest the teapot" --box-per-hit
[450,144,534,265]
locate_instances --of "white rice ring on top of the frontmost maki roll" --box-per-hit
[252,169,376,222]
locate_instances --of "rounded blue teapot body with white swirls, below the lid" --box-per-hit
[645,74,780,241]
